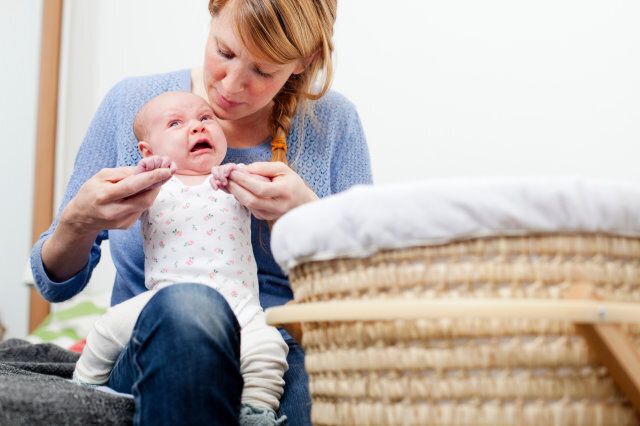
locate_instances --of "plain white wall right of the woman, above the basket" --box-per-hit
[335,0,640,182]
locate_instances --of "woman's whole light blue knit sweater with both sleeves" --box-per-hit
[31,70,371,308]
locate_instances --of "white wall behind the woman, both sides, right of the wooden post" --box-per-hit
[48,0,640,316]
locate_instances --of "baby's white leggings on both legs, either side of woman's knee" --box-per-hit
[73,290,289,410]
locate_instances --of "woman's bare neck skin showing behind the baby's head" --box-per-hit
[191,68,273,148]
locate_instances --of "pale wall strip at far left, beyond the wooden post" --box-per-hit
[0,0,42,337]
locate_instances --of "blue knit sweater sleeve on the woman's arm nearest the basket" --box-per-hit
[331,98,373,194]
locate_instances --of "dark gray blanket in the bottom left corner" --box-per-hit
[0,339,134,425]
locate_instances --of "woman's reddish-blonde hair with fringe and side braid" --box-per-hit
[209,0,336,163]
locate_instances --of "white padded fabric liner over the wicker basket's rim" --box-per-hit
[271,177,640,271]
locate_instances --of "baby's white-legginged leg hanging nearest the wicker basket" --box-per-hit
[240,311,289,411]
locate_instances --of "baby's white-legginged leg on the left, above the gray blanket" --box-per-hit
[73,290,156,385]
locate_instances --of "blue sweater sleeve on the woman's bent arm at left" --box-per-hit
[31,79,124,302]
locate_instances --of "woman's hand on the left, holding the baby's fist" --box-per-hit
[60,167,175,234]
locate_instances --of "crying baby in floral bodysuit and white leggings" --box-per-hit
[74,92,288,424]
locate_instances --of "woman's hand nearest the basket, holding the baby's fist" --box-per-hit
[227,161,318,220]
